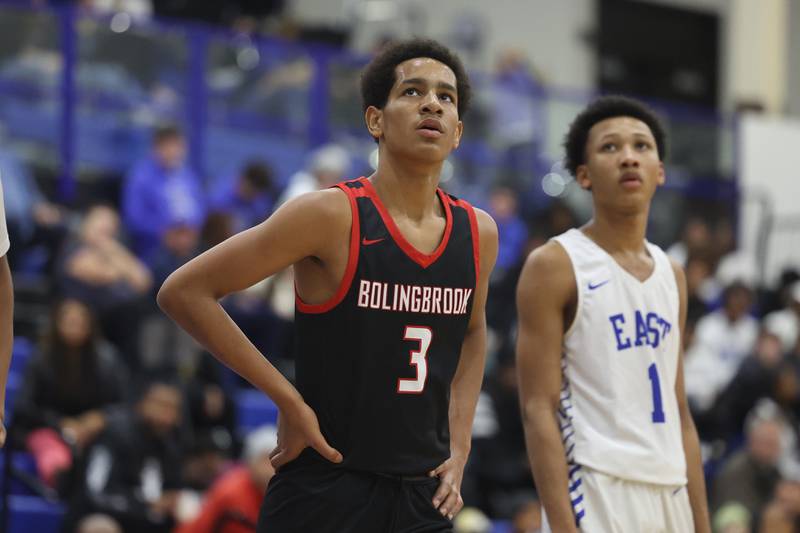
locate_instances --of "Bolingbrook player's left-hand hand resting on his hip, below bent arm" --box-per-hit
[269,402,342,471]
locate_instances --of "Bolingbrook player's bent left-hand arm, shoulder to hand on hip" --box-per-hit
[158,189,352,467]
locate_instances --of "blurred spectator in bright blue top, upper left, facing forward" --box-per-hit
[122,126,206,262]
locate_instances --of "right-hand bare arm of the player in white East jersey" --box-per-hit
[672,260,711,533]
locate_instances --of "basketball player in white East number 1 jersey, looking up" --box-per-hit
[517,97,711,533]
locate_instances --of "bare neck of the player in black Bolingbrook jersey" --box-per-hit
[370,154,442,220]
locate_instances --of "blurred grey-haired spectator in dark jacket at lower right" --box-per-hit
[711,401,791,516]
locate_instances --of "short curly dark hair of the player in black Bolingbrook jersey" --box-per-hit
[361,39,472,117]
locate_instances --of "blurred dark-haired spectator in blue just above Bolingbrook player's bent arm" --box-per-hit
[209,161,276,233]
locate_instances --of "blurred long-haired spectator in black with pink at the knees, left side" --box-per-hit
[14,299,128,487]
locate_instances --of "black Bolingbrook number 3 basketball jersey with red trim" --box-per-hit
[295,178,479,475]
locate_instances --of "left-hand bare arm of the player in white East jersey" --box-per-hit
[517,242,577,533]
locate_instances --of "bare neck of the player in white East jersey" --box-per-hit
[582,210,648,254]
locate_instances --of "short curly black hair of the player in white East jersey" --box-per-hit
[564,96,667,176]
